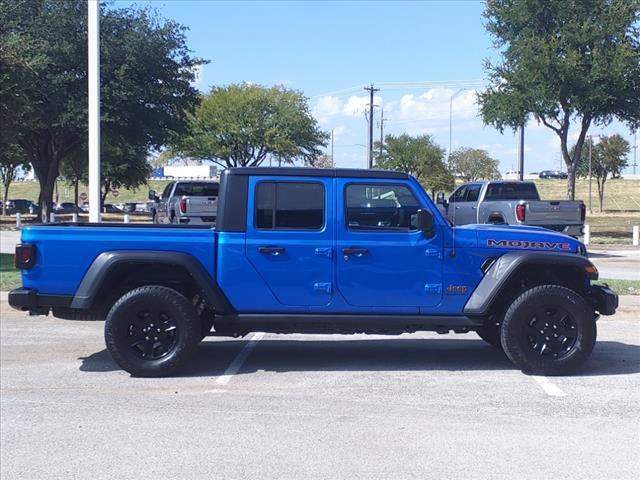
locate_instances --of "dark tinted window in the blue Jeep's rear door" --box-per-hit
[254,182,324,230]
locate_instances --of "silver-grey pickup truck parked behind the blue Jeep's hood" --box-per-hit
[436,180,585,237]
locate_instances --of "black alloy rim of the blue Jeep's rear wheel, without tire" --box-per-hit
[126,308,178,361]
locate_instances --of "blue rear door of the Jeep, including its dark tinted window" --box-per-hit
[246,176,334,307]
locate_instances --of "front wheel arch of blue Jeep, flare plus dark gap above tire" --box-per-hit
[464,252,598,316]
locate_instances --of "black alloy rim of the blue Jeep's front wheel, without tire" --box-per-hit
[525,307,578,359]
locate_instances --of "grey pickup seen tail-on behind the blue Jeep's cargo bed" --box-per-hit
[149,180,220,225]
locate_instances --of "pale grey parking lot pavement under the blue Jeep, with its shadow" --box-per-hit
[0,303,640,479]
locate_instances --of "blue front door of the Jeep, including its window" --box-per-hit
[336,179,442,307]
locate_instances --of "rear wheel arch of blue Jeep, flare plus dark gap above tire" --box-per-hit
[70,250,235,313]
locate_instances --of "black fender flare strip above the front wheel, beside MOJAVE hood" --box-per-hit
[464,251,598,316]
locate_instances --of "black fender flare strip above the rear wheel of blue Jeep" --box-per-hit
[70,250,235,314]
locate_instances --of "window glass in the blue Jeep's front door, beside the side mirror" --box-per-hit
[345,184,420,231]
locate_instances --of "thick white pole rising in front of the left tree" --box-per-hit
[87,0,102,222]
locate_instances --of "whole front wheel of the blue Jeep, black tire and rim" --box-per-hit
[500,285,596,375]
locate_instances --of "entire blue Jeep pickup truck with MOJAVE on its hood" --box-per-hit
[9,168,618,376]
